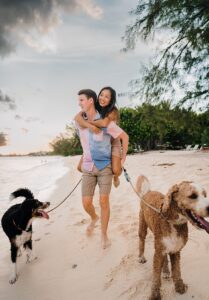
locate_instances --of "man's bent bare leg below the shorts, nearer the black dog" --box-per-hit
[82,196,99,235]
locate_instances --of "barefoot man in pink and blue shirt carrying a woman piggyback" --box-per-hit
[74,89,128,249]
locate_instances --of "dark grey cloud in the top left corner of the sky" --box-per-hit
[0,0,103,57]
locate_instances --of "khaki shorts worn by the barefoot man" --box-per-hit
[81,164,113,197]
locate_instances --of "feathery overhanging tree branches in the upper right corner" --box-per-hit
[124,0,209,108]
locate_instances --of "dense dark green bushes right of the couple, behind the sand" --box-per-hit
[120,102,209,150]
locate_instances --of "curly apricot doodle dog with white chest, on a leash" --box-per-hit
[136,175,209,300]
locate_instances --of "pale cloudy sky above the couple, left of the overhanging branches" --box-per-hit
[0,0,152,154]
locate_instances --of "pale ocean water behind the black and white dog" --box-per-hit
[0,156,68,217]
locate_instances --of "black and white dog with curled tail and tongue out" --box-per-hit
[1,189,50,284]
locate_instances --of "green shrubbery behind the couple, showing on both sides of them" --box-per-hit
[51,102,209,156]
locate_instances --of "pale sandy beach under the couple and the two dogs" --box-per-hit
[0,150,209,300]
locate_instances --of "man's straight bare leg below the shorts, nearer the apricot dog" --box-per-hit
[100,194,110,249]
